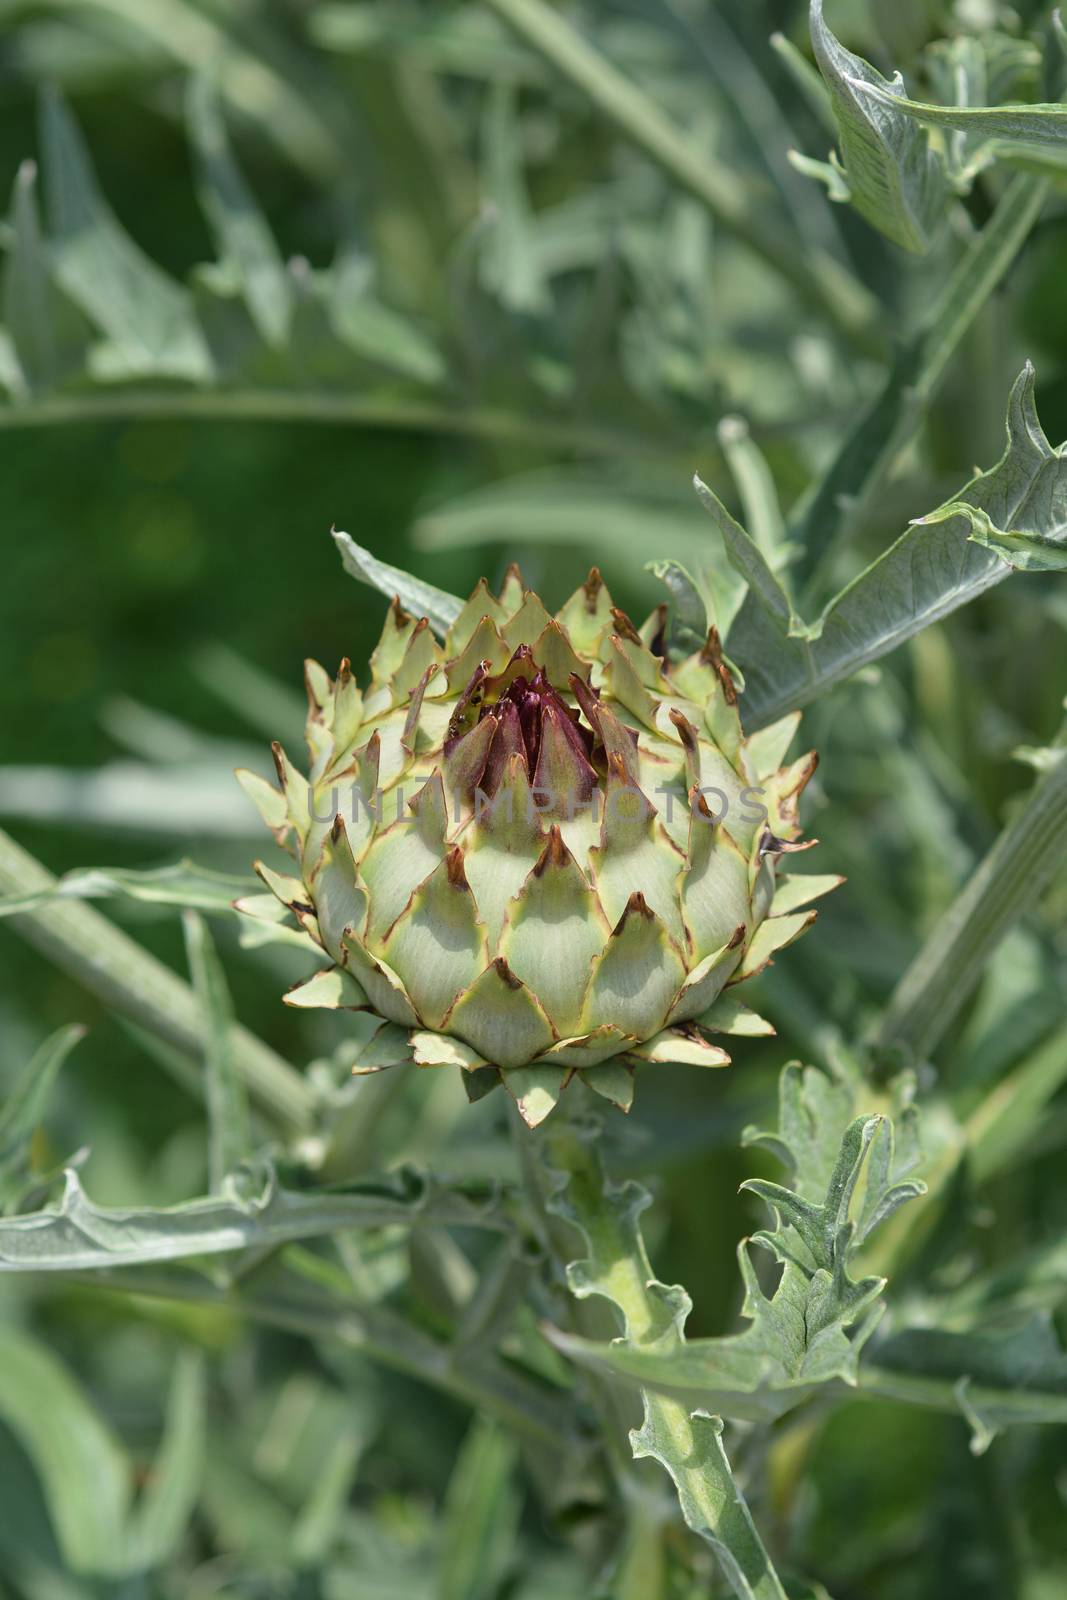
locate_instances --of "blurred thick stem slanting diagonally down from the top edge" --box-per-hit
[479,0,881,350]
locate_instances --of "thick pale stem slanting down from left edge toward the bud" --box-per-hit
[0,829,312,1128]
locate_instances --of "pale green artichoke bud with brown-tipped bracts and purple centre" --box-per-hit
[242,568,838,1122]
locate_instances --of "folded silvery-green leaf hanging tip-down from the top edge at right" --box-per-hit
[811,0,949,254]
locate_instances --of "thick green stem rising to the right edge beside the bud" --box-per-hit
[877,732,1067,1056]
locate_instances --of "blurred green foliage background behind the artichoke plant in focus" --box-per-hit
[0,0,1067,1600]
